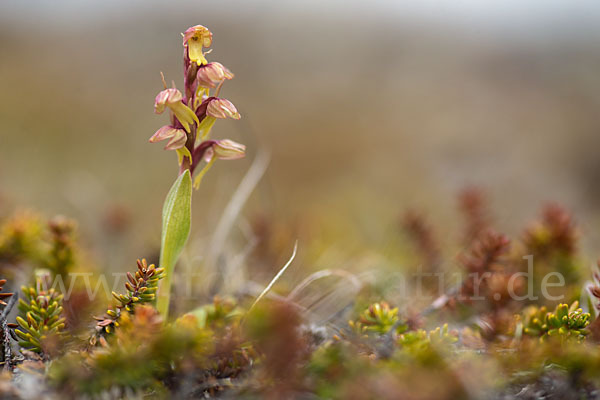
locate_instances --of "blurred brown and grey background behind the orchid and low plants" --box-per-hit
[0,0,600,290]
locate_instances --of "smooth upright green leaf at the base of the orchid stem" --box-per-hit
[157,170,192,319]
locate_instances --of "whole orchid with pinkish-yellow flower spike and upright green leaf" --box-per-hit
[150,25,246,318]
